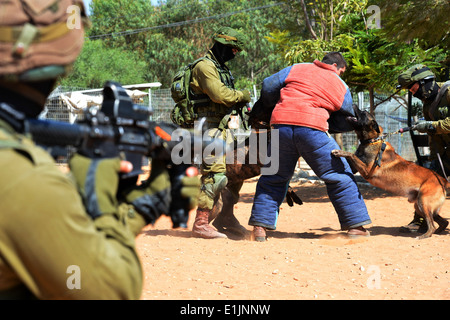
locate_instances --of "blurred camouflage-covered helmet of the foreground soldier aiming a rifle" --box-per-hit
[0,0,86,82]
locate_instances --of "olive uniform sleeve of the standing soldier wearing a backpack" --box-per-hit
[191,60,244,107]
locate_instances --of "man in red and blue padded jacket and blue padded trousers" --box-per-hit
[249,52,371,242]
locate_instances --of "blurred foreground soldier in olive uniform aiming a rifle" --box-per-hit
[0,0,199,299]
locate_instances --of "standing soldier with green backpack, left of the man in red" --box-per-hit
[190,27,250,239]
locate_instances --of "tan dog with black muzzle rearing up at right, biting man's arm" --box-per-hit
[332,105,450,239]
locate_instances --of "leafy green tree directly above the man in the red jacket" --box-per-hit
[271,0,446,113]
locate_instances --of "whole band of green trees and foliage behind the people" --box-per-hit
[61,0,450,105]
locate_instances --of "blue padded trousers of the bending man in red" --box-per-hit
[249,125,371,230]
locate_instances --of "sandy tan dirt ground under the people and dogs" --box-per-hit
[137,170,450,300]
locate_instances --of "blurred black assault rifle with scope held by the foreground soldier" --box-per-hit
[24,81,217,228]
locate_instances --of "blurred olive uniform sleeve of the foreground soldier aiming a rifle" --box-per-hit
[0,148,145,299]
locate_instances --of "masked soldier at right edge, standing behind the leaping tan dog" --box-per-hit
[397,64,450,233]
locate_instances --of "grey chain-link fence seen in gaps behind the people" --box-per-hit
[40,87,416,161]
